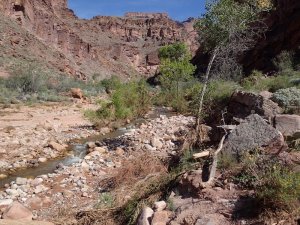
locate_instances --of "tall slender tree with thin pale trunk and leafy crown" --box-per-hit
[195,0,265,127]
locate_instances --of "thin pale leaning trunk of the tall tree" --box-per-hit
[196,48,218,135]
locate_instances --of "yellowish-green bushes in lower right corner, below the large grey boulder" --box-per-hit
[225,150,300,210]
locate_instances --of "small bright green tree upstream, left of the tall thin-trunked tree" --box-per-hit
[159,43,196,108]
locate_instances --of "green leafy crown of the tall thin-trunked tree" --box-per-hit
[195,0,259,51]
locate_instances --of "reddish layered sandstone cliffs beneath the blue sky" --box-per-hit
[0,0,197,79]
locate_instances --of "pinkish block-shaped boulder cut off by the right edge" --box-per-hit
[275,115,300,138]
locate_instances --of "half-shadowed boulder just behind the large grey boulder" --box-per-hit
[228,91,283,119]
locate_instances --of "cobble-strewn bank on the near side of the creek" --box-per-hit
[0,109,194,223]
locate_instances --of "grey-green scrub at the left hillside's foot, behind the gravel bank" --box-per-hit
[0,63,103,103]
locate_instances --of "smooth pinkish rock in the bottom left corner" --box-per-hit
[3,202,33,221]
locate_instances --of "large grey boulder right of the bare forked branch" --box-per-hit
[223,114,285,155]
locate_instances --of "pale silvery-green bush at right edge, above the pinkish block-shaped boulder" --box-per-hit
[272,87,300,108]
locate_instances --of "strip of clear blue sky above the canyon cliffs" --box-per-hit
[68,0,205,21]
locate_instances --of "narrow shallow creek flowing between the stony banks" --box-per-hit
[0,108,174,188]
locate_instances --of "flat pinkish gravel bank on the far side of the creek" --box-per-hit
[0,102,99,174]
